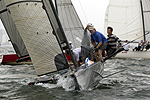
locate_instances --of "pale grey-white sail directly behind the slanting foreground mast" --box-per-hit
[56,0,84,48]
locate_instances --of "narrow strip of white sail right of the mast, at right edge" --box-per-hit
[141,0,150,41]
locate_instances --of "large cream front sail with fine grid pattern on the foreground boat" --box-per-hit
[4,0,66,75]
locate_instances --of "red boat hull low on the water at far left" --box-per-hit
[1,54,32,65]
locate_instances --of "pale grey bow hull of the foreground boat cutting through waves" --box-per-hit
[75,62,104,90]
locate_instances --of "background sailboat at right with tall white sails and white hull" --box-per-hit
[104,0,150,59]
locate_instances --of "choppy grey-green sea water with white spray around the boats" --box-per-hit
[0,47,150,100]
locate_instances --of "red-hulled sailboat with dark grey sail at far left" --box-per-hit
[0,1,32,64]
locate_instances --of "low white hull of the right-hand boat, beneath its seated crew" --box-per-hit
[114,50,150,59]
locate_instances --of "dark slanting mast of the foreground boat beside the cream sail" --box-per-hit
[42,0,78,70]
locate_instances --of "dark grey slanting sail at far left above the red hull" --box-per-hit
[0,1,28,57]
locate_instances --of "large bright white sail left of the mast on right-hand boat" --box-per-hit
[105,0,144,40]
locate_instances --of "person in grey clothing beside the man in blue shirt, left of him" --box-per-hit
[81,23,94,62]
